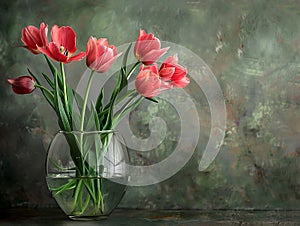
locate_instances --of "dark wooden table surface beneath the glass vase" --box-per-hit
[0,208,300,226]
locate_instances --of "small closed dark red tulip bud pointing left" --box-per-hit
[7,75,35,94]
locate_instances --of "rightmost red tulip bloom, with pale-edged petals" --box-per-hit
[159,54,190,88]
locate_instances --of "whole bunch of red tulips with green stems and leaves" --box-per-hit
[8,23,189,215]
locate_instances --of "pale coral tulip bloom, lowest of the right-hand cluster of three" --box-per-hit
[135,64,170,98]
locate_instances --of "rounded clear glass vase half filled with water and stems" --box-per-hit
[46,131,129,220]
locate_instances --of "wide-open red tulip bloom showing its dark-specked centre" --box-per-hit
[38,25,85,63]
